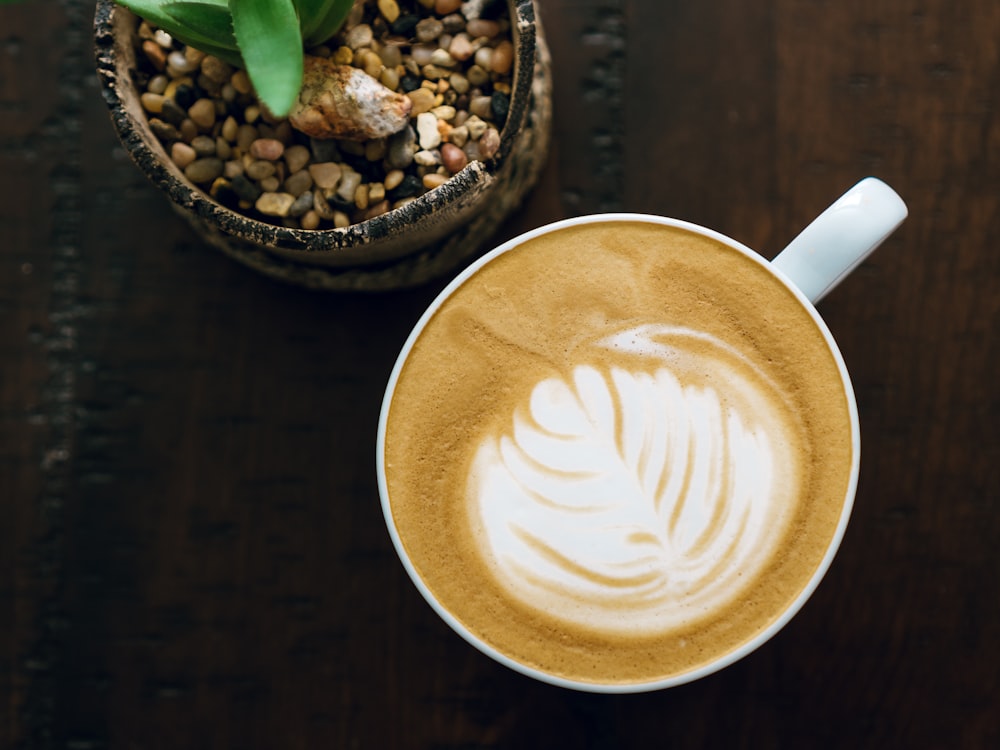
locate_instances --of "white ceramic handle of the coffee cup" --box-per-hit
[771,177,908,304]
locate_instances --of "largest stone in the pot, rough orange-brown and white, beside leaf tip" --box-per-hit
[289,55,413,141]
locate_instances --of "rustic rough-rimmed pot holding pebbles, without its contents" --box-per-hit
[95,0,551,290]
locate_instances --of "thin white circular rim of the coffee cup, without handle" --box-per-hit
[375,212,861,694]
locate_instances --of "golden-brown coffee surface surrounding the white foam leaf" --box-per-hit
[384,221,854,684]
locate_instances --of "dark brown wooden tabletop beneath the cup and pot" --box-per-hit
[0,0,1000,750]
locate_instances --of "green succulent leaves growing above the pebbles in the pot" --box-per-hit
[116,0,353,117]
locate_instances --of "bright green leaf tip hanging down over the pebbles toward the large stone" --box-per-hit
[229,0,303,117]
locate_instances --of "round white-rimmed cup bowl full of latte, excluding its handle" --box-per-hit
[377,214,860,692]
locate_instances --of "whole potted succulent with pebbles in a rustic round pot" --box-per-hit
[95,0,551,289]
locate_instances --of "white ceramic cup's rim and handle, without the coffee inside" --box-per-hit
[376,177,907,693]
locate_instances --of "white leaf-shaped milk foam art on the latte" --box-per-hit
[468,325,800,632]
